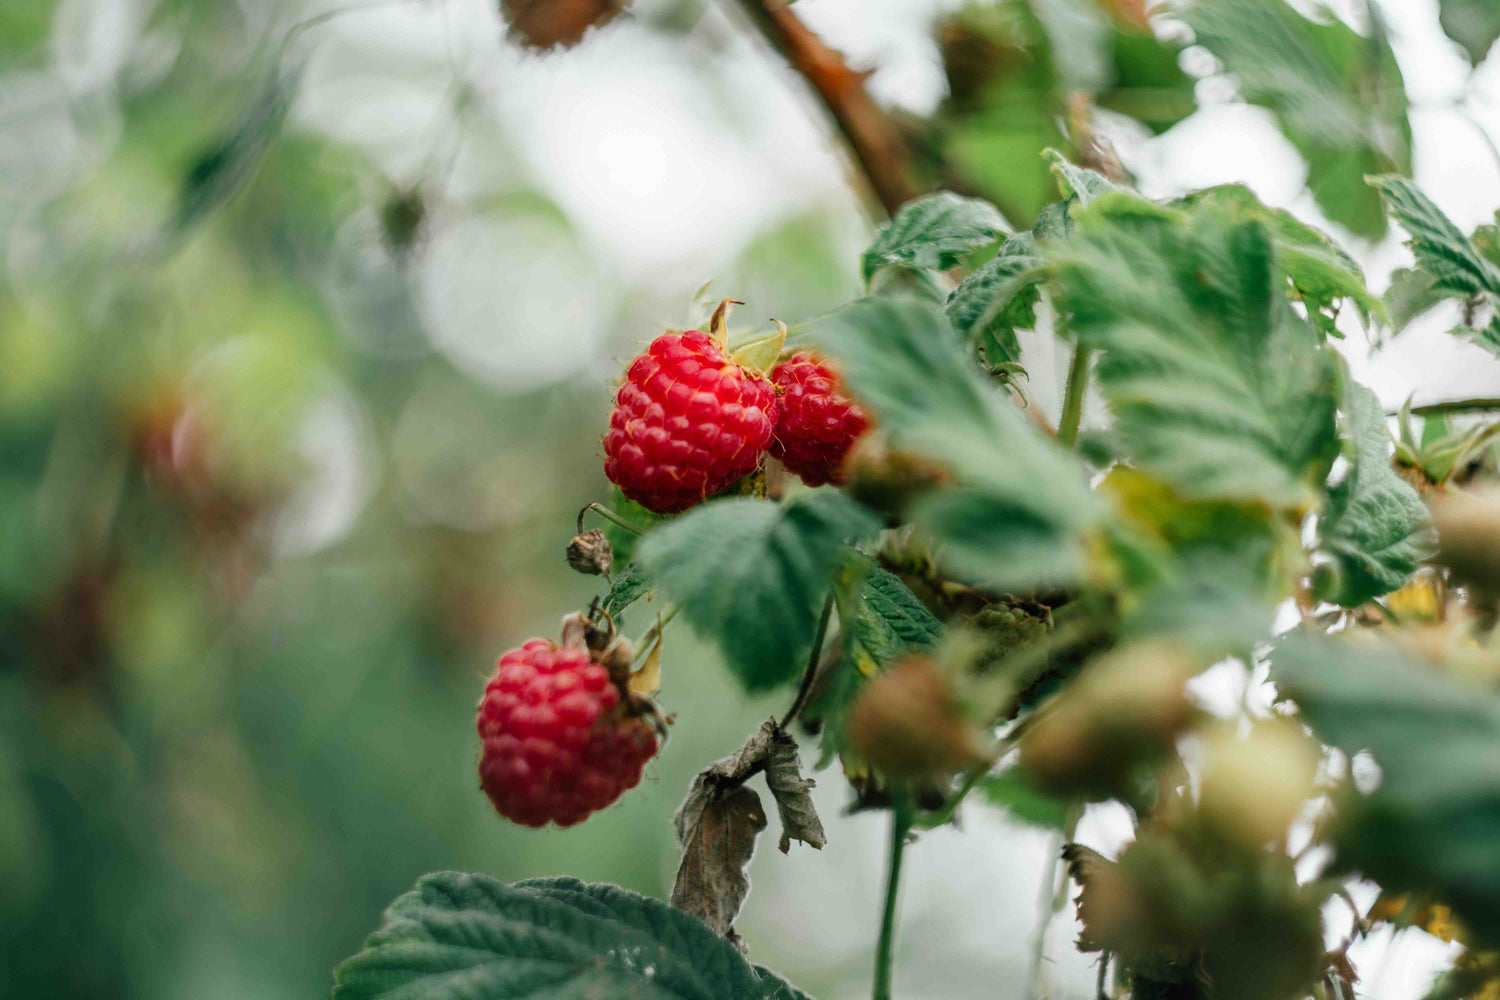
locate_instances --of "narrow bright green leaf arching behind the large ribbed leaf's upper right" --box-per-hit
[1176,184,1385,336]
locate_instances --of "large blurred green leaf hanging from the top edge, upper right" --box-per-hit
[1182,0,1412,240]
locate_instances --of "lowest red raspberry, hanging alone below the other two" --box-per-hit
[477,639,657,826]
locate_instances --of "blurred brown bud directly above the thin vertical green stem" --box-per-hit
[849,657,983,778]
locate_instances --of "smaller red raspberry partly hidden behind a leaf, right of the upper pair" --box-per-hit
[771,351,870,486]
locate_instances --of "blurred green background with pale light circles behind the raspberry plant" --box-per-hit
[0,0,1500,1000]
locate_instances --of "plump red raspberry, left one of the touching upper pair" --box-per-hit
[605,330,777,514]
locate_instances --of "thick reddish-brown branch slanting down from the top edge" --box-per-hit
[723,0,921,214]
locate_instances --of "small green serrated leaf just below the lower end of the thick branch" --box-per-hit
[860,190,1005,282]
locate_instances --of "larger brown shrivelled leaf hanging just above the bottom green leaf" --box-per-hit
[672,775,765,951]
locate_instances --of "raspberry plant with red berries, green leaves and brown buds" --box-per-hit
[335,0,1500,1000]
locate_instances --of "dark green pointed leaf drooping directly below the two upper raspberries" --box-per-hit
[636,492,881,691]
